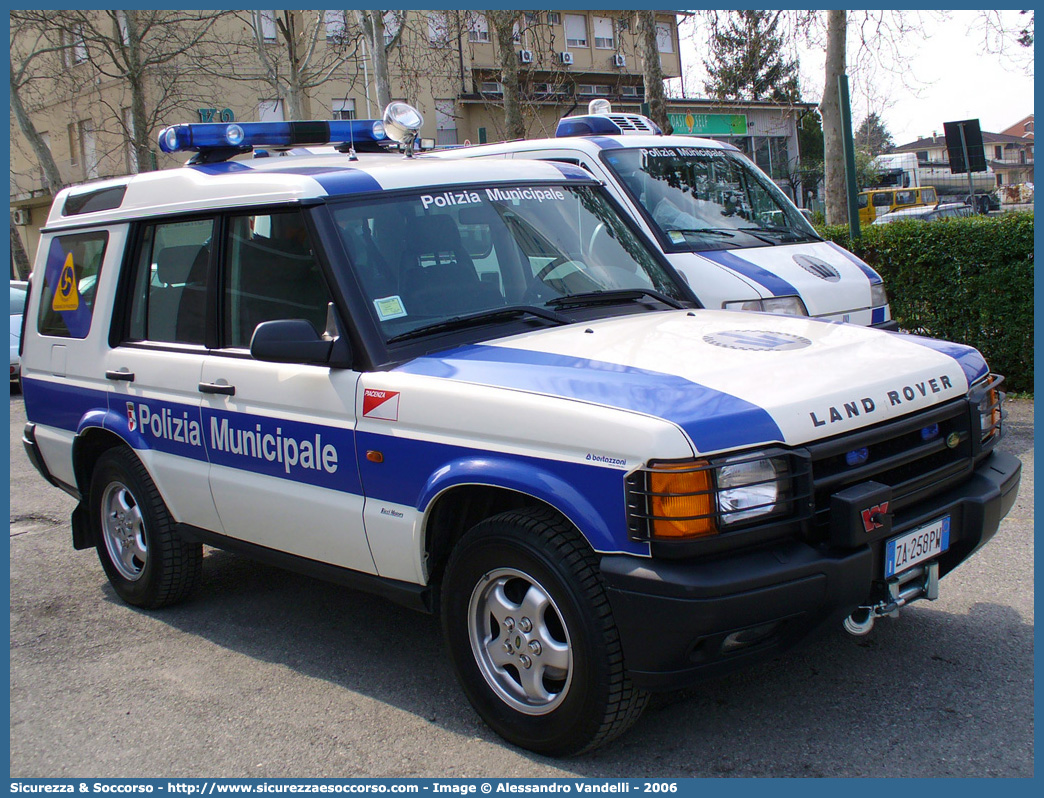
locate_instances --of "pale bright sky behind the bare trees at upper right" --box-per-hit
[680,10,1034,145]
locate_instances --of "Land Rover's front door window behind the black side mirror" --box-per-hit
[223,211,332,349]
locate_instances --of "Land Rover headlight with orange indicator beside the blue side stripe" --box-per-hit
[628,451,793,540]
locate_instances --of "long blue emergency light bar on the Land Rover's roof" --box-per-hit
[160,119,387,152]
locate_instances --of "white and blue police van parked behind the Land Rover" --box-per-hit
[437,99,898,330]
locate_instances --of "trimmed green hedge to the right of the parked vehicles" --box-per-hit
[818,212,1034,392]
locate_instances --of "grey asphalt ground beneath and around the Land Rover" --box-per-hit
[10,397,1034,778]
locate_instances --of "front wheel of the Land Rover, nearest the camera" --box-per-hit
[442,508,646,756]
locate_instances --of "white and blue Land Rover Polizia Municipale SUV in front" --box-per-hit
[22,107,1021,755]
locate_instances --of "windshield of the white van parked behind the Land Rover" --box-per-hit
[601,147,818,251]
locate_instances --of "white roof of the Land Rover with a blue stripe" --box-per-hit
[47,151,591,228]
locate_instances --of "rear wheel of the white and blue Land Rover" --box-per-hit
[90,447,203,609]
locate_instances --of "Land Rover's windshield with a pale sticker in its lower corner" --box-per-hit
[331,184,687,341]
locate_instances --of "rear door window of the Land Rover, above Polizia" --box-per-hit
[127,219,214,345]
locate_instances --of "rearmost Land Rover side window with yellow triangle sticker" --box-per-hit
[37,230,109,338]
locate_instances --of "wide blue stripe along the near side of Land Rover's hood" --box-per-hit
[396,346,783,452]
